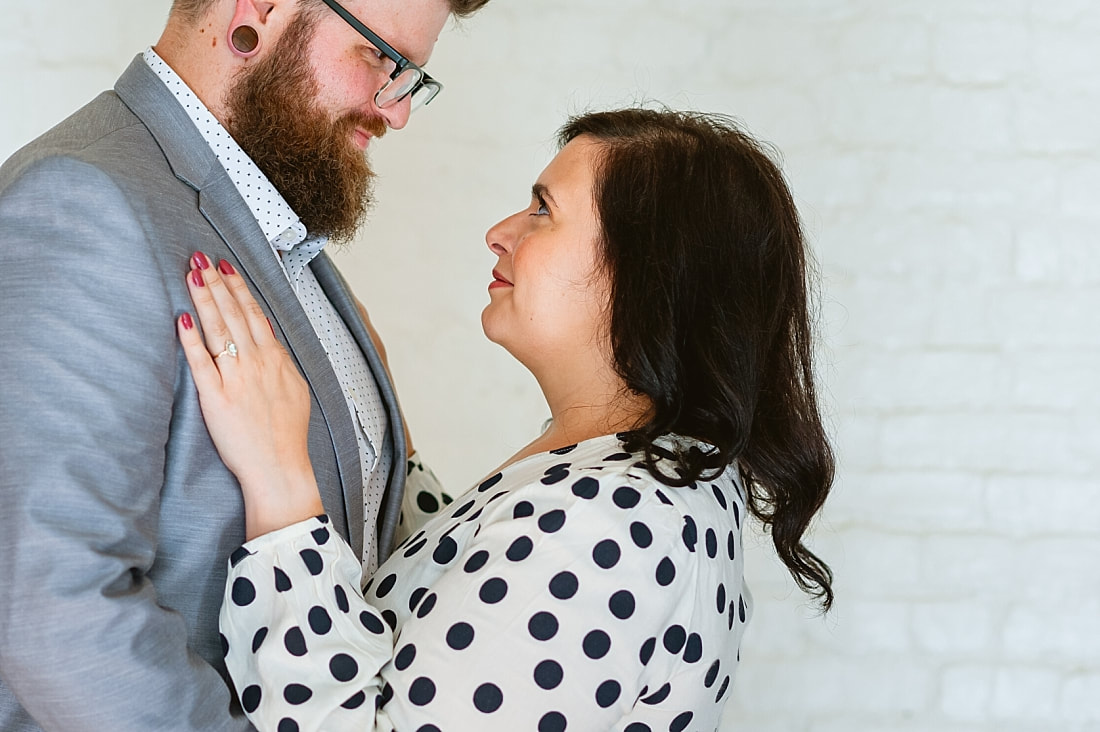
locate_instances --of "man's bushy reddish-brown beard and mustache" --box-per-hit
[226,14,386,241]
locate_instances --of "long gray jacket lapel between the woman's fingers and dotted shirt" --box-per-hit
[116,56,363,556]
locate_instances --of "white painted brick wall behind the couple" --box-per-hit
[0,0,1100,732]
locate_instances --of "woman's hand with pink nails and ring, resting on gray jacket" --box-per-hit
[177,252,325,539]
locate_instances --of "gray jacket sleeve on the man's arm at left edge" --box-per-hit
[0,157,249,730]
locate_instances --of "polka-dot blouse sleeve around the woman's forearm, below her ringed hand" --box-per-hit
[220,516,394,732]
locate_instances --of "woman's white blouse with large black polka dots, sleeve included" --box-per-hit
[221,436,751,732]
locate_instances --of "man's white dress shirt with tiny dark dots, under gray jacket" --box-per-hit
[144,48,415,571]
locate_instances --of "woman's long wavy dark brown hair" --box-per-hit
[559,109,834,610]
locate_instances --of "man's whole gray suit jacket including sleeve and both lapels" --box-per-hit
[0,57,406,732]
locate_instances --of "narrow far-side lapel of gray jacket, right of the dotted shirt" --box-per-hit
[310,252,408,564]
